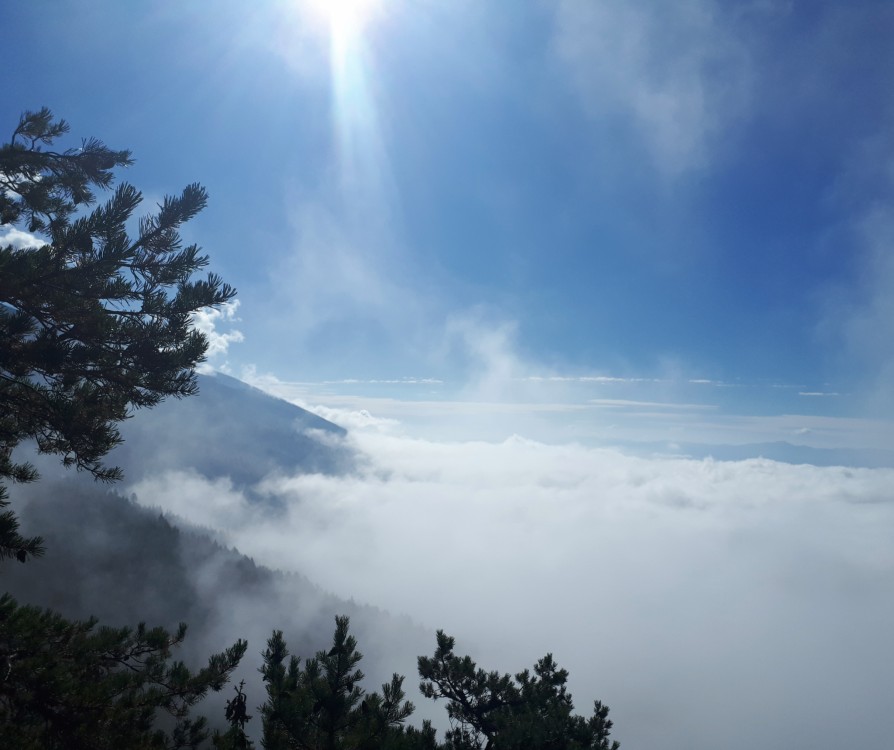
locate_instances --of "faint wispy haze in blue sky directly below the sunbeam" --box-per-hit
[252,188,441,379]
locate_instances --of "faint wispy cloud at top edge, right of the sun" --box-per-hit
[554,0,752,177]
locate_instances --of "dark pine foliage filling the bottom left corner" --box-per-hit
[0,595,246,750]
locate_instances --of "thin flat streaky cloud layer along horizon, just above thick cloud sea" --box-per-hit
[243,371,892,458]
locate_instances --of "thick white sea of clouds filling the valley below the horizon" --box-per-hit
[131,432,894,750]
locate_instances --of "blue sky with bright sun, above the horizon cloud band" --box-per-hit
[0,0,894,442]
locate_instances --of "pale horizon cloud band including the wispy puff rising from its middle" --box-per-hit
[242,358,892,452]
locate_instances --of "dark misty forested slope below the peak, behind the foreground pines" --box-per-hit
[3,482,434,732]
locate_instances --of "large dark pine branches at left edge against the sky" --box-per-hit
[0,108,235,562]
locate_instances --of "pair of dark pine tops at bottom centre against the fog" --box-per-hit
[260,617,620,750]
